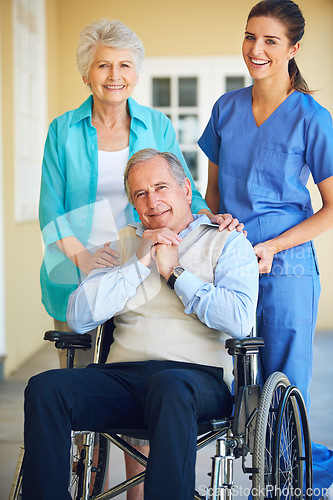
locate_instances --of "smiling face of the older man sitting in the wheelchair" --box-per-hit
[128,156,193,233]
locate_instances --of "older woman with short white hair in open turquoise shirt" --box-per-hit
[40,19,237,498]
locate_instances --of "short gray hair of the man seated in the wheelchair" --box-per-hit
[124,148,187,206]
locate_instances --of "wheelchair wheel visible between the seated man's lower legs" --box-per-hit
[70,433,110,500]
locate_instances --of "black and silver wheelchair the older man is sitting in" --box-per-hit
[9,325,312,500]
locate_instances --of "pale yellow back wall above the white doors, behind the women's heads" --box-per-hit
[54,0,333,112]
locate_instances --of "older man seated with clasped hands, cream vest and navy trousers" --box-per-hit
[23,150,258,500]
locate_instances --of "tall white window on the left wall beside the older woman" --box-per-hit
[13,0,46,222]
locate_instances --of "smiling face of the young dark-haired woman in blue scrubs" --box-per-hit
[242,16,299,80]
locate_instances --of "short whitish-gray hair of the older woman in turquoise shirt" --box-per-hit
[76,18,145,77]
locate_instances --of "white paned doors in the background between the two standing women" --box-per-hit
[134,57,251,194]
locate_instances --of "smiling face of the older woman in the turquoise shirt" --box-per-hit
[83,45,138,107]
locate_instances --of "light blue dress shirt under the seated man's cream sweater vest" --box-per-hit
[67,215,258,337]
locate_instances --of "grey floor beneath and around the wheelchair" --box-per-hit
[0,332,333,500]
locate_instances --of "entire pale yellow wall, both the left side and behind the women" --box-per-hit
[0,0,333,374]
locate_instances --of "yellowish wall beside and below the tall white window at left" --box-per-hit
[0,0,55,375]
